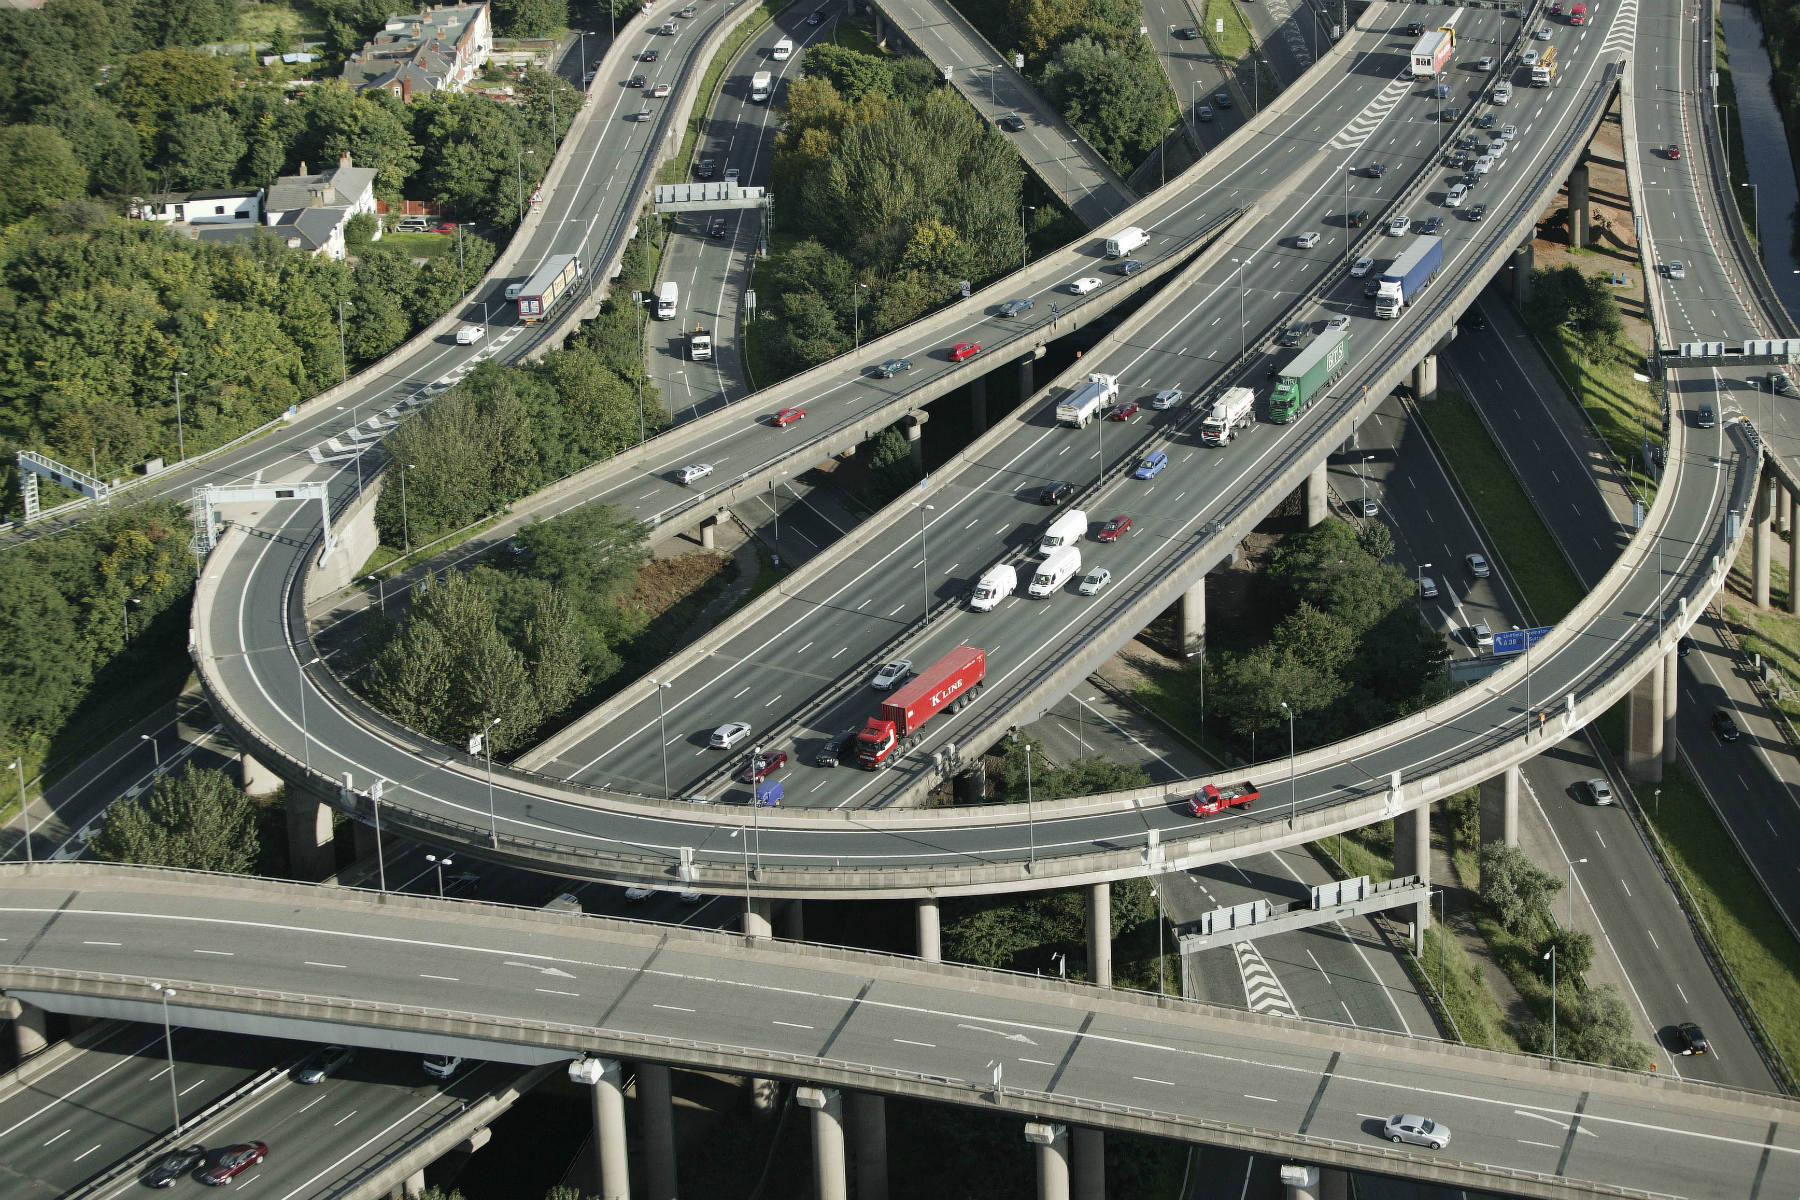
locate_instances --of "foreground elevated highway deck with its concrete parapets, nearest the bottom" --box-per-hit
[0,864,1800,1198]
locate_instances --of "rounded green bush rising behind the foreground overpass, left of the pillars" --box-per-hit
[94,763,261,874]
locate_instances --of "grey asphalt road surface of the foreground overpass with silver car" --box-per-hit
[0,867,1800,1196]
